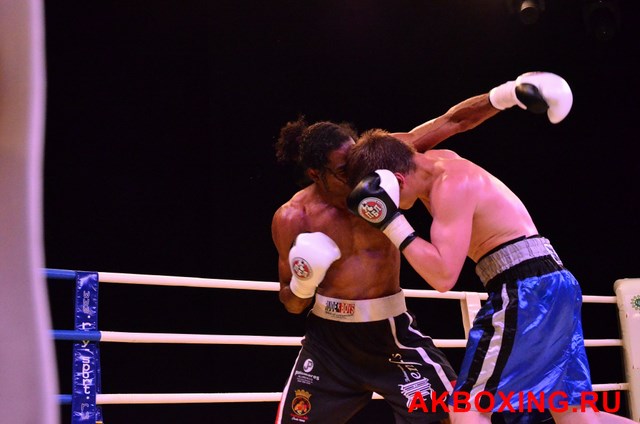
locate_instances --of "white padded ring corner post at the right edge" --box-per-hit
[613,278,640,421]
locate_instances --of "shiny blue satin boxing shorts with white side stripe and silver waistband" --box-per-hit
[449,237,592,411]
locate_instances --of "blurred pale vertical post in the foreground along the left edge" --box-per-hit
[0,0,60,424]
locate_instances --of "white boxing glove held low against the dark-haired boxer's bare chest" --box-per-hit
[289,232,341,299]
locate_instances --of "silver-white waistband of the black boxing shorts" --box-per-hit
[311,291,407,322]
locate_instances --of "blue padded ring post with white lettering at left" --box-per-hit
[71,271,102,424]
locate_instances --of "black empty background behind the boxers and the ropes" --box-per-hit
[44,0,640,424]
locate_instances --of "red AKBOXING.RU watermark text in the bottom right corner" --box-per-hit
[409,391,620,413]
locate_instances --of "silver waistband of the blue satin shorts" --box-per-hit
[476,237,562,286]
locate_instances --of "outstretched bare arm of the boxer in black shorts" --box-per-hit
[391,93,500,152]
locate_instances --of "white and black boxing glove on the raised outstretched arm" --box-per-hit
[489,72,573,124]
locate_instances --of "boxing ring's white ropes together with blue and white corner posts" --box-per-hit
[44,269,640,424]
